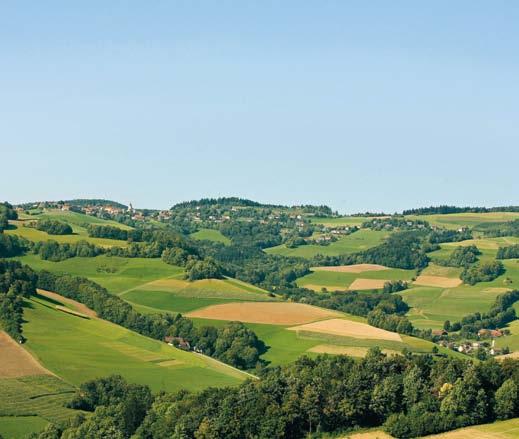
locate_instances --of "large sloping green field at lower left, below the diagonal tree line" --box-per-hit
[23,298,250,391]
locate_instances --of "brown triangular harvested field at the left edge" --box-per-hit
[0,331,51,378]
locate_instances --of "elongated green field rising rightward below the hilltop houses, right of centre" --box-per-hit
[265,229,388,258]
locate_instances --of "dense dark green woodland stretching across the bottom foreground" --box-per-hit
[30,354,519,439]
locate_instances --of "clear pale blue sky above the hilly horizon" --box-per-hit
[0,0,519,213]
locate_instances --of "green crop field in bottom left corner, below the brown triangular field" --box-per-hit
[0,375,79,438]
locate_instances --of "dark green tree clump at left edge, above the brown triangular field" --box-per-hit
[0,262,37,341]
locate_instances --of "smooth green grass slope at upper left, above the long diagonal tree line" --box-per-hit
[16,255,183,294]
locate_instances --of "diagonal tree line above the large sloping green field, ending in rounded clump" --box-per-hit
[38,271,264,368]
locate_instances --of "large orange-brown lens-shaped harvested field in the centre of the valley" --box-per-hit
[186,302,341,325]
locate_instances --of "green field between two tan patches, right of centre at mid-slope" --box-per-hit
[297,268,416,291]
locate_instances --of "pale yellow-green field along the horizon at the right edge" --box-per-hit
[406,212,519,229]
